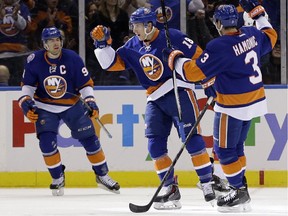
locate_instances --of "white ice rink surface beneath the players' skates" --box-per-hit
[0,187,288,216]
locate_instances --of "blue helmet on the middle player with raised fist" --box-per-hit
[130,7,157,26]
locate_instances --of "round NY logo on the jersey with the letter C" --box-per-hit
[43,76,67,99]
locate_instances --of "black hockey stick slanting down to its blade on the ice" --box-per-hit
[129,97,214,213]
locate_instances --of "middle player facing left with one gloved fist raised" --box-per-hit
[91,8,215,209]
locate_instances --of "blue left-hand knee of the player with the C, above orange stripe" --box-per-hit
[38,132,57,153]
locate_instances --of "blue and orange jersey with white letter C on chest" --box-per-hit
[22,49,93,110]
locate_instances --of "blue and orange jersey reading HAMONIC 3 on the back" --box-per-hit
[176,24,277,120]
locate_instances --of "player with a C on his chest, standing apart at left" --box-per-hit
[18,27,120,196]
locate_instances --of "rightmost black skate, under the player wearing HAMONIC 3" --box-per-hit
[217,176,251,212]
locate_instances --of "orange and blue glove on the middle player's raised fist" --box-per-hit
[90,25,112,49]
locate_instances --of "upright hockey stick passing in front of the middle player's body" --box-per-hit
[161,0,185,142]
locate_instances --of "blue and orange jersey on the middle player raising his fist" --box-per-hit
[101,29,202,98]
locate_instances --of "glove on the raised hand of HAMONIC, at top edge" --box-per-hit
[239,0,265,20]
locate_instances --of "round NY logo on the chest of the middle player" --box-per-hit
[139,54,163,81]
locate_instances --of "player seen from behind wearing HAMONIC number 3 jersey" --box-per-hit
[163,0,277,211]
